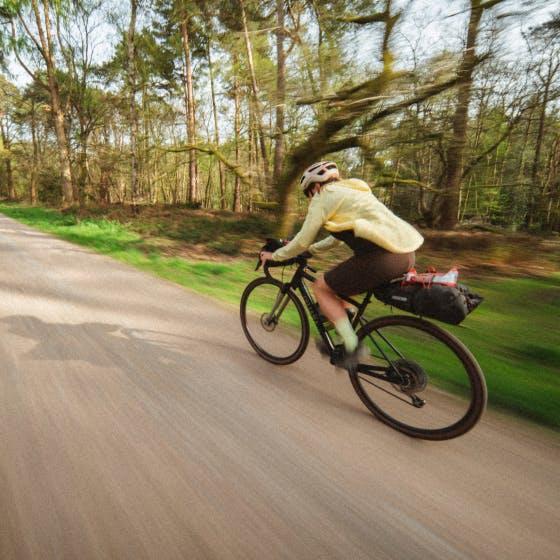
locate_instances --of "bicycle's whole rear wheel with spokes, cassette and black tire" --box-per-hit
[350,315,486,440]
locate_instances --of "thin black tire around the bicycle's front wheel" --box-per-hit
[240,277,309,365]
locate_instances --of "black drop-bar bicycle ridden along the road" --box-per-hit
[240,247,487,440]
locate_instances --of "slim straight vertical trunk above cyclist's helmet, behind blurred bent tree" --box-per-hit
[272,0,286,192]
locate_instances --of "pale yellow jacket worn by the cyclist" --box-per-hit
[272,179,424,261]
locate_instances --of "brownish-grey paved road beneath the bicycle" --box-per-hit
[0,212,560,560]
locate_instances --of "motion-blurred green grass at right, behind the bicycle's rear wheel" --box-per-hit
[442,275,560,428]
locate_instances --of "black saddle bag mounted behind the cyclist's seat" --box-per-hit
[373,279,483,325]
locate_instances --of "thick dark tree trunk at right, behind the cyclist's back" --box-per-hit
[439,0,483,229]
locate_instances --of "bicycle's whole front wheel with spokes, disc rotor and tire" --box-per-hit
[240,277,309,365]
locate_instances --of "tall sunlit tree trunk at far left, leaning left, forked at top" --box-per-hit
[31,0,74,206]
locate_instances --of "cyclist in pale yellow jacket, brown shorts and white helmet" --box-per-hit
[261,161,424,364]
